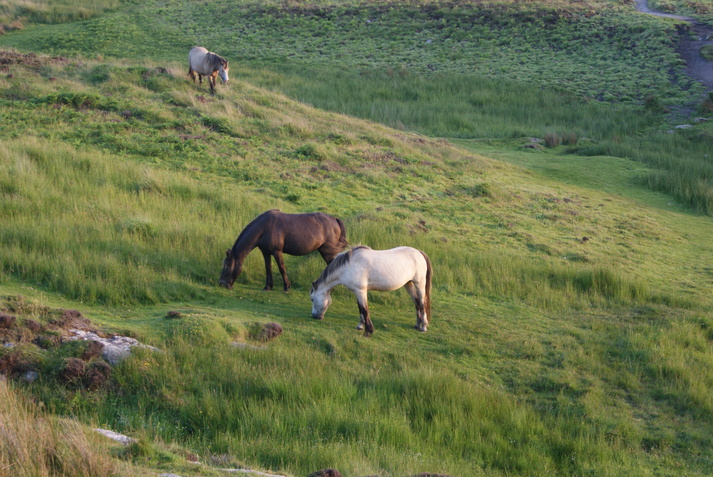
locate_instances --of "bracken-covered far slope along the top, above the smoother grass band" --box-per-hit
[1,0,700,102]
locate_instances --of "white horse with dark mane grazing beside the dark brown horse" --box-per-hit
[309,246,433,336]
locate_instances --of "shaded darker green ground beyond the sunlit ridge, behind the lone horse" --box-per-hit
[0,1,713,215]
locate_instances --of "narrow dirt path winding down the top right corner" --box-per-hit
[636,0,713,91]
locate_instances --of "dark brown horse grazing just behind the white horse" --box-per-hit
[220,210,347,291]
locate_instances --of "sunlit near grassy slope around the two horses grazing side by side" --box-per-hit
[0,49,711,475]
